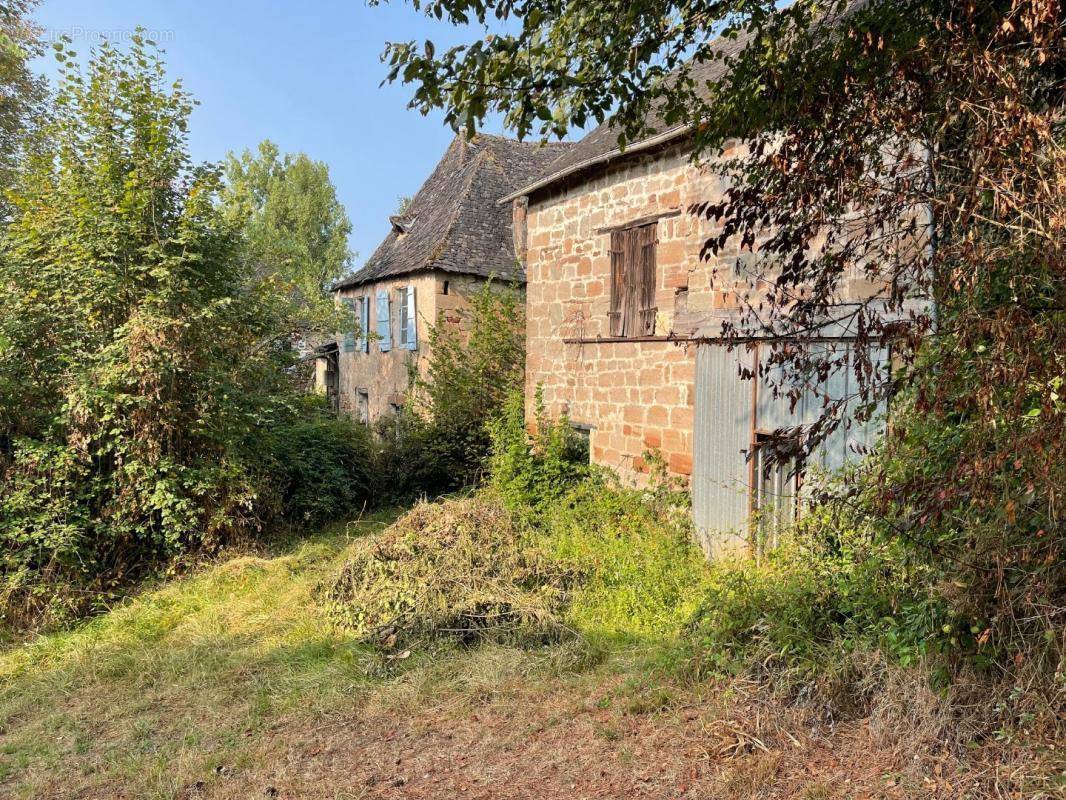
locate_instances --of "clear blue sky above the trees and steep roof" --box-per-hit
[34,0,550,266]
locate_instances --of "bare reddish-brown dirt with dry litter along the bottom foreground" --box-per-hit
[185,678,970,800]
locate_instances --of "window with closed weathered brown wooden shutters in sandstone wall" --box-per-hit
[608,222,659,338]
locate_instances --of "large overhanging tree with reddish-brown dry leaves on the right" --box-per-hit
[384,0,1066,662]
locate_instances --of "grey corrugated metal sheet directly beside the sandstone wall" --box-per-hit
[692,345,752,556]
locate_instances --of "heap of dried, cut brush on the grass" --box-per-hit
[320,495,569,649]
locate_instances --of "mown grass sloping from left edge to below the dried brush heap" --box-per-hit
[0,512,703,798]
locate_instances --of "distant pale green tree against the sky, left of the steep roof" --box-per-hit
[222,141,352,333]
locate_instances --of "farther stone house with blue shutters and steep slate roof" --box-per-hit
[326,135,568,422]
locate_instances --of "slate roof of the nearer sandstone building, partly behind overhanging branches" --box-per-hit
[500,33,747,204]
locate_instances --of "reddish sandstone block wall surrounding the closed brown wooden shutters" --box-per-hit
[527,142,743,482]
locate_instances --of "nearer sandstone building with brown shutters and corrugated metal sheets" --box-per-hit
[503,63,903,553]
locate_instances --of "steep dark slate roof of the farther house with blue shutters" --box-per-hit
[334,134,574,290]
